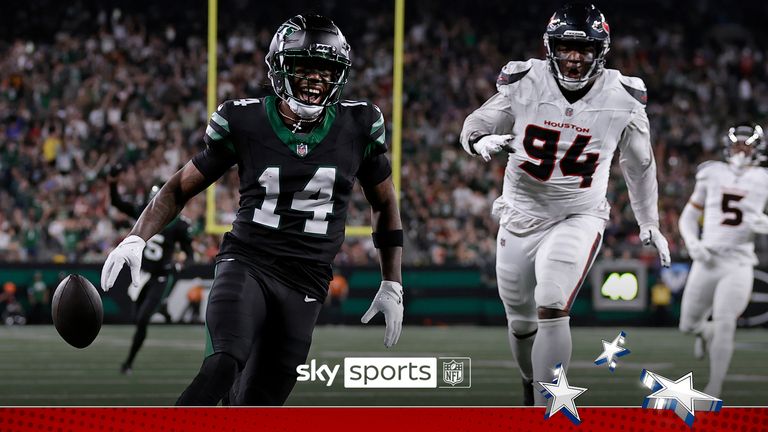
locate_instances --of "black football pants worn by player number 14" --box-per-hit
[176,259,322,406]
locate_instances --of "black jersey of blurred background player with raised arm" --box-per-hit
[109,184,193,274]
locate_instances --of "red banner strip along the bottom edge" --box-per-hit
[0,407,768,432]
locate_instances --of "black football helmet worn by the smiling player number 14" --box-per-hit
[264,15,352,120]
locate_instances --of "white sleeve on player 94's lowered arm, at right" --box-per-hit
[619,108,659,227]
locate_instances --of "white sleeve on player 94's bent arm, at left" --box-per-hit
[459,93,515,156]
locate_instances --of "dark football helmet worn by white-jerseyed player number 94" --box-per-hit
[544,3,611,91]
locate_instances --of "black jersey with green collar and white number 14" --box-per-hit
[192,96,391,265]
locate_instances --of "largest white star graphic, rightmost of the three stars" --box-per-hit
[640,370,723,426]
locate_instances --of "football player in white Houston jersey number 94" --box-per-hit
[461,4,669,405]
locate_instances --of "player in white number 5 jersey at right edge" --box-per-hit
[680,124,768,397]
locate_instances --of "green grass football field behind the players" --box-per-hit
[0,325,768,406]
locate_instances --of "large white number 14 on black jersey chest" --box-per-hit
[253,167,336,234]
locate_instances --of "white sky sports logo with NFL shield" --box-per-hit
[296,357,472,388]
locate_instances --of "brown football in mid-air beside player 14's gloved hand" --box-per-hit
[51,274,104,348]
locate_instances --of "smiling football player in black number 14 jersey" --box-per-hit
[101,15,403,405]
